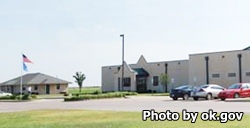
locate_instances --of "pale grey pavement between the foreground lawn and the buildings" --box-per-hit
[0,96,250,114]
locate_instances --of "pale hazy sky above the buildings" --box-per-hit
[0,0,250,87]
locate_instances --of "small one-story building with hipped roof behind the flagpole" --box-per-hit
[0,73,71,94]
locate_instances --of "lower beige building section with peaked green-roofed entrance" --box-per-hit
[102,56,189,92]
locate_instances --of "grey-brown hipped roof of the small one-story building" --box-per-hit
[0,73,71,86]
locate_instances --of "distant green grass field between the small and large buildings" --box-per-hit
[68,87,101,94]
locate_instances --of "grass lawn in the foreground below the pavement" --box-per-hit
[0,110,250,128]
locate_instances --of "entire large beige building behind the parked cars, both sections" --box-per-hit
[102,47,250,92]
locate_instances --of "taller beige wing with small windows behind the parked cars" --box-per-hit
[189,48,250,87]
